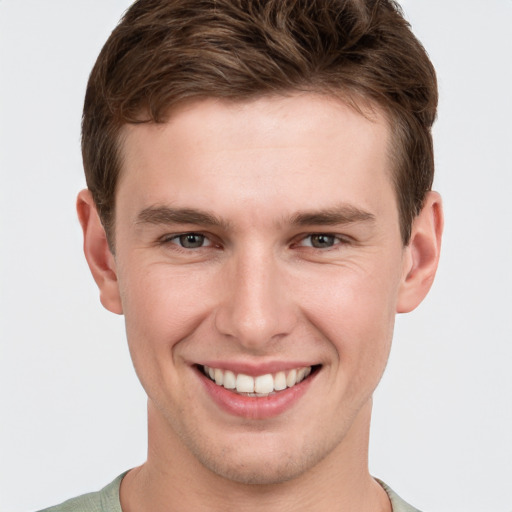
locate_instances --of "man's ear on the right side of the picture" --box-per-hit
[397,192,443,313]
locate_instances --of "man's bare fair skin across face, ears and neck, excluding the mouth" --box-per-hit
[78,94,442,512]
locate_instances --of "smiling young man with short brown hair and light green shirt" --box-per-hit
[42,0,442,512]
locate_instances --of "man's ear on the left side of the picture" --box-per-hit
[76,189,123,315]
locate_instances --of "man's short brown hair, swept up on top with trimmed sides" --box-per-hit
[82,0,437,247]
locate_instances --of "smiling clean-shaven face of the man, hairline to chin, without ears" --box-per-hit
[111,94,406,483]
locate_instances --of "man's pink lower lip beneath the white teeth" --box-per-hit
[198,370,317,420]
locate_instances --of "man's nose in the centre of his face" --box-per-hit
[215,246,297,353]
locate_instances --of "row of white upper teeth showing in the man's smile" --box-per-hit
[203,366,311,397]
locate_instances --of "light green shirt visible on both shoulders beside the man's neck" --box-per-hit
[40,473,420,512]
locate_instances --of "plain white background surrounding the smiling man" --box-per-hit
[0,0,512,512]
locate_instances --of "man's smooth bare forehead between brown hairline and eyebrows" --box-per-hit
[118,94,391,223]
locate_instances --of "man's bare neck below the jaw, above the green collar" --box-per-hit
[120,400,391,512]
